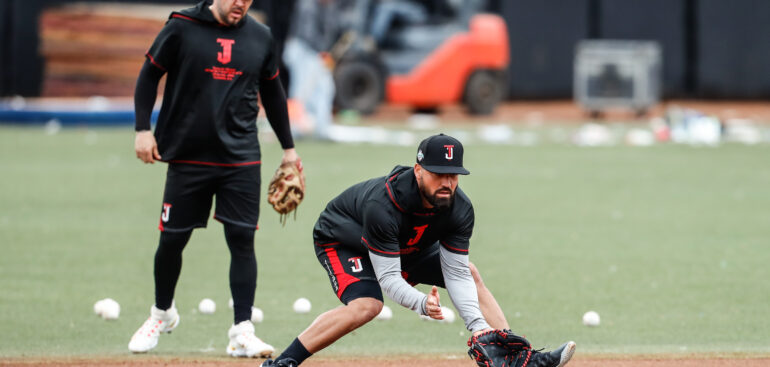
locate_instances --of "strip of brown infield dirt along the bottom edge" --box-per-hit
[0,355,770,367]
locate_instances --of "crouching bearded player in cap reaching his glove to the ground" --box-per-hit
[262,134,575,367]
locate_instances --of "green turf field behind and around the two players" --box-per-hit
[0,126,770,357]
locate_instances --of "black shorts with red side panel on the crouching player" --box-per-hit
[315,241,444,304]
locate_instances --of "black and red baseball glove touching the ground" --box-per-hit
[468,329,532,367]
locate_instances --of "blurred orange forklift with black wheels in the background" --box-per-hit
[331,0,509,115]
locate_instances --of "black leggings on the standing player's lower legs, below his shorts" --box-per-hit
[154,224,257,324]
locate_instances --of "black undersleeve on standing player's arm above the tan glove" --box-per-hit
[259,74,294,149]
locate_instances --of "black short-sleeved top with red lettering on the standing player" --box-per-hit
[147,1,278,165]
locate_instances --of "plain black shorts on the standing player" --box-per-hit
[158,163,260,232]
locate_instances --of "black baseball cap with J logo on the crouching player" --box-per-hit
[417,134,470,175]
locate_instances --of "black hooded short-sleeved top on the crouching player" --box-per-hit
[313,166,474,261]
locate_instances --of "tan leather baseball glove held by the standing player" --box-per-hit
[267,162,305,224]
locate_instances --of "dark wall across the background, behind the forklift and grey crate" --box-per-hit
[0,0,770,99]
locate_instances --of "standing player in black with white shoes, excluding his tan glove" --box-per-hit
[128,0,301,357]
